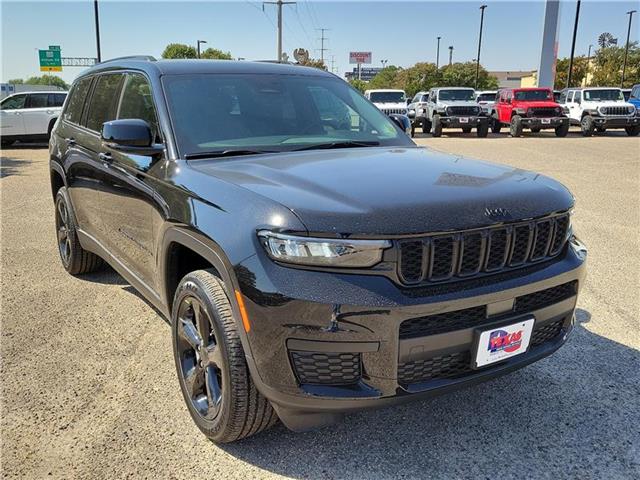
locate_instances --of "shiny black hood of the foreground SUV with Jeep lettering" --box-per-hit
[190,147,573,236]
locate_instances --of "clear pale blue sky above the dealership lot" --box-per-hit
[0,0,640,82]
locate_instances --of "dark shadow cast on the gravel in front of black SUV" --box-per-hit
[218,309,640,479]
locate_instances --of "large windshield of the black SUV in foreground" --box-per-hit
[162,74,413,156]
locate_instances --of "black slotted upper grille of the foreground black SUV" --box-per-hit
[397,213,570,285]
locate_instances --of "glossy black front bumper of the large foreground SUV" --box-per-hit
[236,236,586,430]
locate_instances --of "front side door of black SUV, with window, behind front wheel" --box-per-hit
[100,72,163,291]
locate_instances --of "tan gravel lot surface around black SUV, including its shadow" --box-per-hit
[0,132,640,479]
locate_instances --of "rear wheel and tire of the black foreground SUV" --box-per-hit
[55,187,104,275]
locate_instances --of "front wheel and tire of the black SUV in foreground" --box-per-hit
[171,270,278,443]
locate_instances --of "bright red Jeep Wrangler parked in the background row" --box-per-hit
[491,88,569,137]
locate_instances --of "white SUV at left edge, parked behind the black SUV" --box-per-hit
[0,91,67,147]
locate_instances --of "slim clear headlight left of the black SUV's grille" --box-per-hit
[258,231,391,267]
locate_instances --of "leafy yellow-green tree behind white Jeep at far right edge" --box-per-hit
[590,42,640,88]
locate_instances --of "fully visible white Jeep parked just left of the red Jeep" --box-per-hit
[426,87,489,137]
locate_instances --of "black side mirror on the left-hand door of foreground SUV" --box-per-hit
[102,118,164,155]
